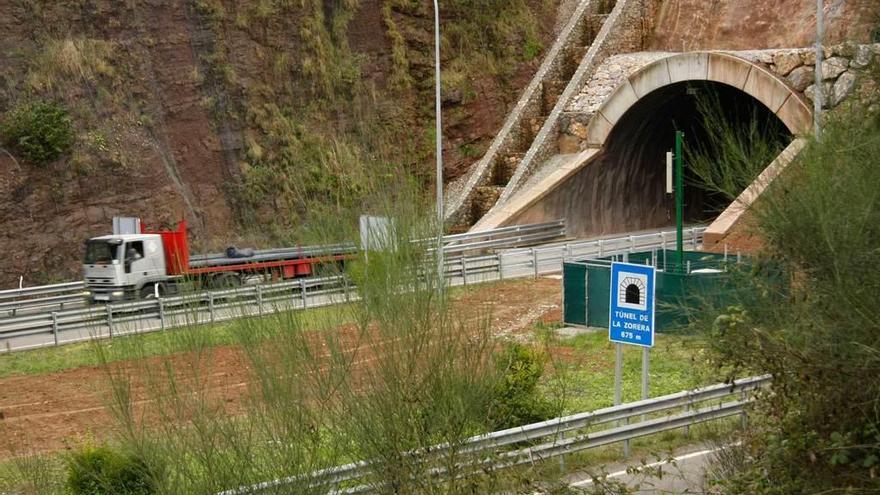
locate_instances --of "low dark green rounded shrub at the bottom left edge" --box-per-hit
[67,446,155,495]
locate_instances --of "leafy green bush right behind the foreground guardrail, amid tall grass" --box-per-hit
[489,344,553,430]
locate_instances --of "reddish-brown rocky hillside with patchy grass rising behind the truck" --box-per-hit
[0,0,571,288]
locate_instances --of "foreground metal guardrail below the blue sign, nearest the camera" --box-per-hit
[218,375,772,495]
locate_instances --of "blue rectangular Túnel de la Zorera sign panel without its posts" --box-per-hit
[608,263,656,347]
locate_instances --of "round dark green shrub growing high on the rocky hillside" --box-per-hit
[0,101,74,164]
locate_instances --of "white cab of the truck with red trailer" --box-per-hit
[83,234,168,301]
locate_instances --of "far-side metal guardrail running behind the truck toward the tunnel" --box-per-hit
[0,220,565,316]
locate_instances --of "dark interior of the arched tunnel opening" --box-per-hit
[582,81,791,234]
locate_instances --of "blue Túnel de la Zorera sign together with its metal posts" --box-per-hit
[608,262,657,456]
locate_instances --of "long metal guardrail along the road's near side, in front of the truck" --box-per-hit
[0,227,705,352]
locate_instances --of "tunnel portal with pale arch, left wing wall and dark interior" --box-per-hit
[488,52,812,237]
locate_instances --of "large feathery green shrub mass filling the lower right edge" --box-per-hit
[707,90,880,494]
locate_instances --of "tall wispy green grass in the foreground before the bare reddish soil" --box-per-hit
[67,181,550,493]
